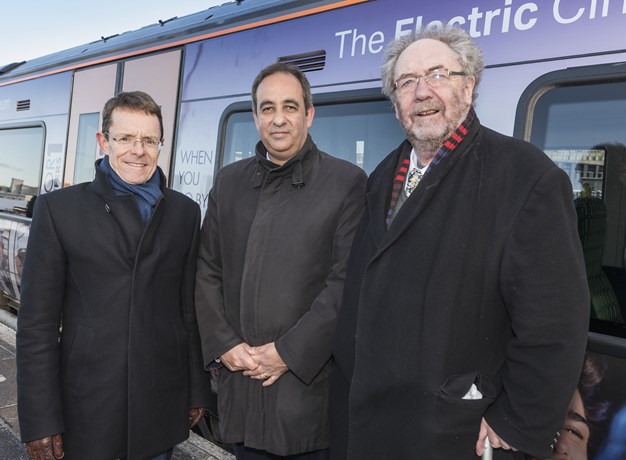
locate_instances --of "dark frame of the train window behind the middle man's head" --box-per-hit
[214,88,405,174]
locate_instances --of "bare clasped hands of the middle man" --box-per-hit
[220,342,289,387]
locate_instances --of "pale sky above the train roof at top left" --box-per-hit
[0,0,231,67]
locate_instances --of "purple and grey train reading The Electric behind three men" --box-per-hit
[0,0,626,458]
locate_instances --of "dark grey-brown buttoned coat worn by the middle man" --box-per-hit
[196,138,366,455]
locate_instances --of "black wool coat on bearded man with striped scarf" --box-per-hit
[330,120,589,460]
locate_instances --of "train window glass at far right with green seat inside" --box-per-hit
[530,82,626,335]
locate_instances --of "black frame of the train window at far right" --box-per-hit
[513,64,626,342]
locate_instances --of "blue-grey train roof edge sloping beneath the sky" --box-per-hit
[0,0,349,81]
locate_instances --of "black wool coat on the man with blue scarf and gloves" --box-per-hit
[17,167,210,460]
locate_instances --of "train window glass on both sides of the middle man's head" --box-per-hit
[223,100,404,174]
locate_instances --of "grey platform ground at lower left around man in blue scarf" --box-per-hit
[0,310,235,460]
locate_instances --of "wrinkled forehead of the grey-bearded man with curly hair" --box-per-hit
[394,38,463,78]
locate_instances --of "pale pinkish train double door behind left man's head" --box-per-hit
[64,50,182,185]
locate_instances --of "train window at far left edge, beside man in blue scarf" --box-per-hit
[0,126,45,214]
